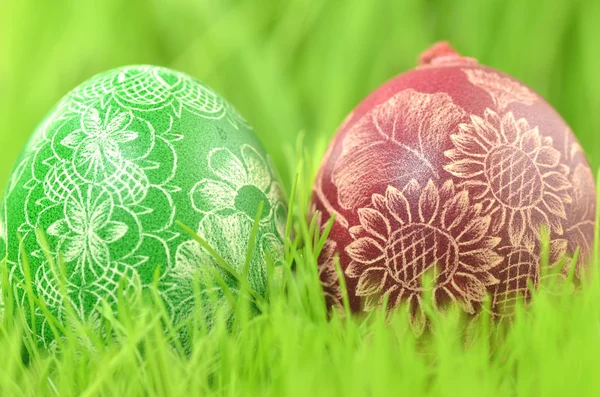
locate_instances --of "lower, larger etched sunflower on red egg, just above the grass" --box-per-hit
[345,179,502,331]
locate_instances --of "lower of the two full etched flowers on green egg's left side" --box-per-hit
[48,185,128,283]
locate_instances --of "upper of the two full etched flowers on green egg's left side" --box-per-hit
[61,107,138,182]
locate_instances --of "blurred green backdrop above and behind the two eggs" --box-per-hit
[0,0,600,192]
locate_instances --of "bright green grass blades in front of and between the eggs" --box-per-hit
[0,155,600,396]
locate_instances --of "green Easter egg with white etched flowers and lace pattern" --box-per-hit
[0,66,287,343]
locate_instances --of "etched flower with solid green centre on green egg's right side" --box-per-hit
[190,145,285,230]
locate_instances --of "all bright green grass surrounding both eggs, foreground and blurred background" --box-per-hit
[0,0,600,396]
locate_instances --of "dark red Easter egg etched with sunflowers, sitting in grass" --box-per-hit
[313,43,596,331]
